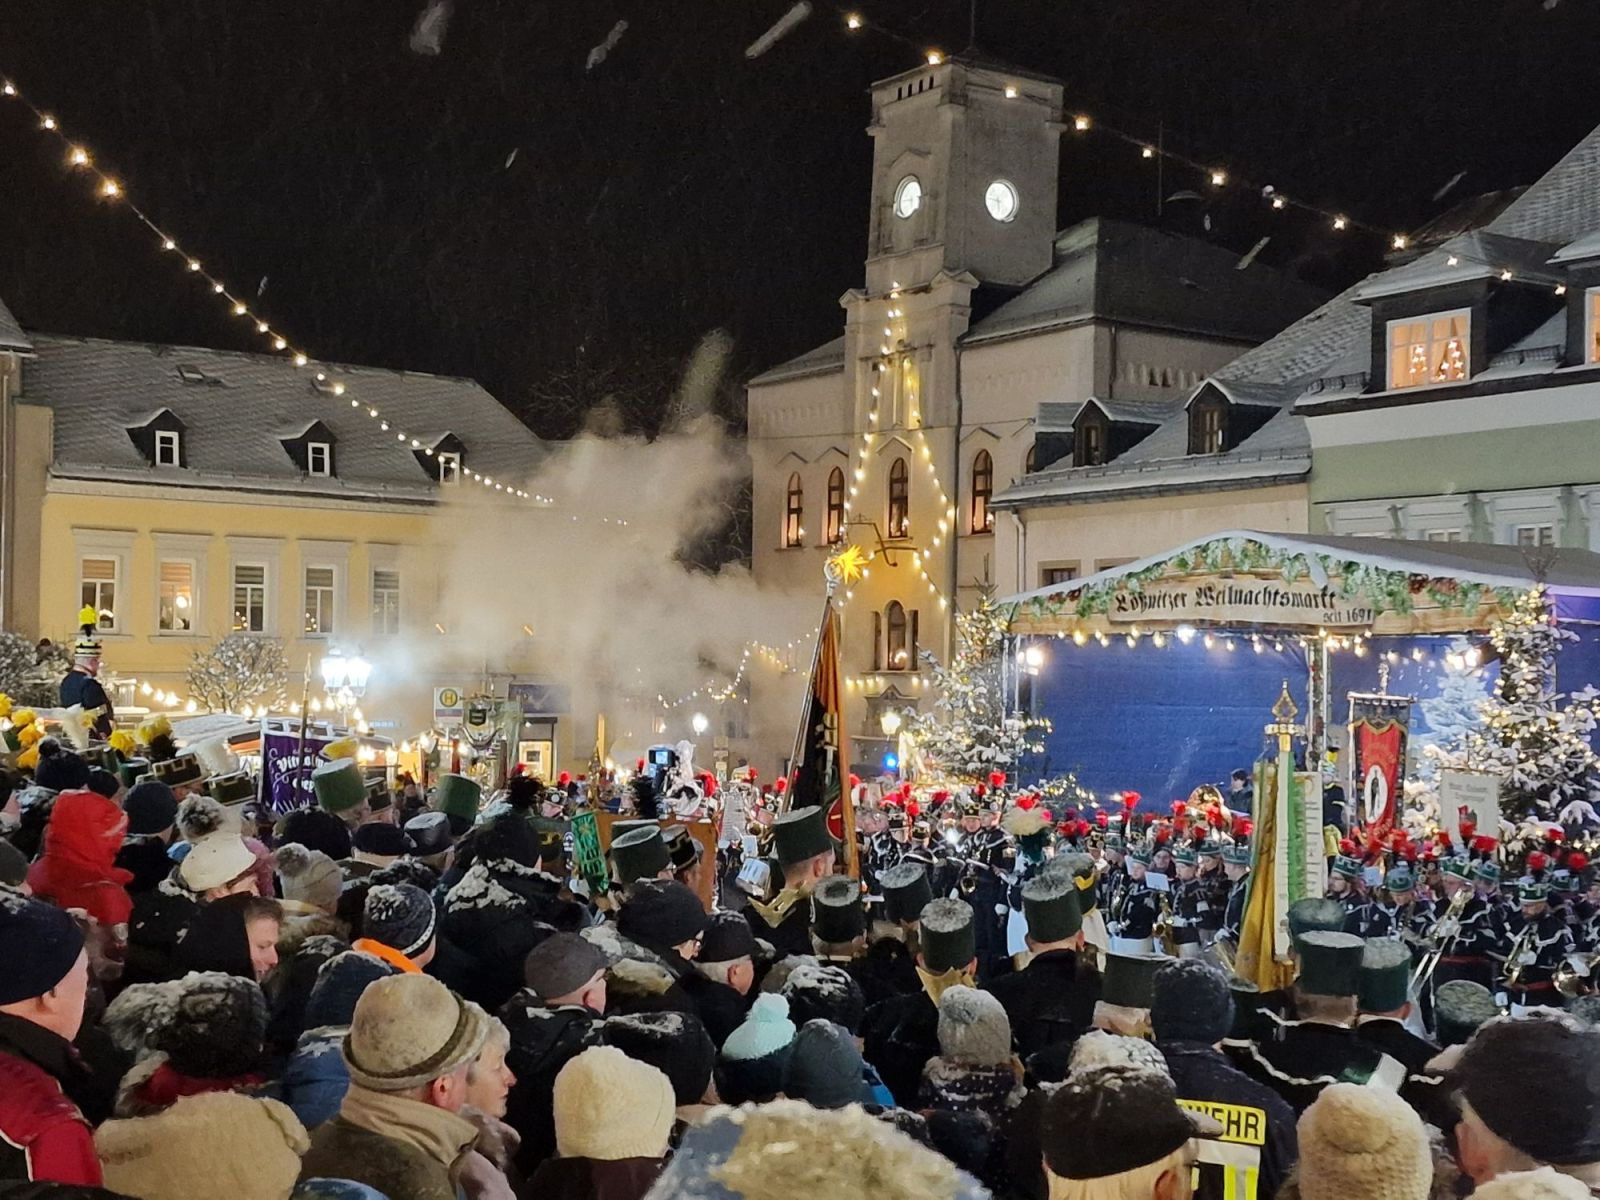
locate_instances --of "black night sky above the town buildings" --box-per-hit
[0,0,1600,437]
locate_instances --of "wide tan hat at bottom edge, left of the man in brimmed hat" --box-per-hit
[94,1091,310,1200]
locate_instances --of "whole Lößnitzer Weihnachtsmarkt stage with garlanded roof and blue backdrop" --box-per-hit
[1002,531,1600,844]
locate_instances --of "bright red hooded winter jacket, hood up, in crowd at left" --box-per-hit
[27,790,133,925]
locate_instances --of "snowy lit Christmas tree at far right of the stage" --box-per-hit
[1437,584,1600,851]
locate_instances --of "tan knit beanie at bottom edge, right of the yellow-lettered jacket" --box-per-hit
[1299,1083,1434,1200]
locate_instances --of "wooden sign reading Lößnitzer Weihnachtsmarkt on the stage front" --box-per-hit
[1106,574,1376,629]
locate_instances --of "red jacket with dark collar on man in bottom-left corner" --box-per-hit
[0,1016,101,1187]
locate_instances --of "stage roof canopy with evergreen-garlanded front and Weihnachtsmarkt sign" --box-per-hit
[1003,530,1600,634]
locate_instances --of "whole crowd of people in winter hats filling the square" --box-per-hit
[0,732,1600,1200]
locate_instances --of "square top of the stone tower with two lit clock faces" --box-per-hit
[867,54,1064,294]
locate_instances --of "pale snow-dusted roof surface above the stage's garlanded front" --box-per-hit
[1002,530,1600,605]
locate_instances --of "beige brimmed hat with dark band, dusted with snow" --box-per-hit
[344,974,490,1091]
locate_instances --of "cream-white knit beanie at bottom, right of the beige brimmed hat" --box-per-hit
[552,1046,677,1162]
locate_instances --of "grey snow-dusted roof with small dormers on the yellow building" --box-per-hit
[19,334,546,502]
